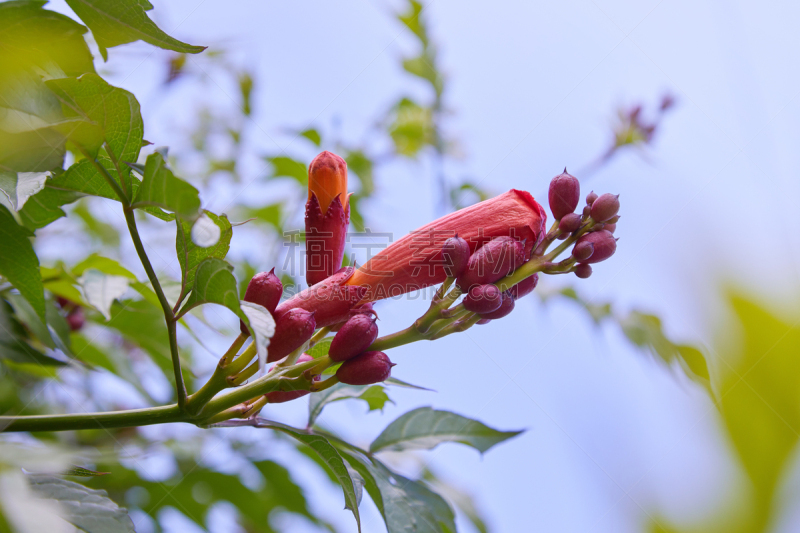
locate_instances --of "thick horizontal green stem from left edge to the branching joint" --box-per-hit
[0,404,183,431]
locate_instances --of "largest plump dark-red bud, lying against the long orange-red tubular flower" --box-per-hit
[458,237,525,291]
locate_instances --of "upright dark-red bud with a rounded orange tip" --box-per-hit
[306,152,350,285]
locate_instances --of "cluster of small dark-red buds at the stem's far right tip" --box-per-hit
[548,169,619,278]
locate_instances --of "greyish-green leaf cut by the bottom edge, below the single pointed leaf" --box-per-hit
[340,450,456,533]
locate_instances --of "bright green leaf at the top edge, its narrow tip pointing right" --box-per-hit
[67,0,206,60]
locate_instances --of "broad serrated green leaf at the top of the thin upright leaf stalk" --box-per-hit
[46,73,144,179]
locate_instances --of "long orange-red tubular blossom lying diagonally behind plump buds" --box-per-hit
[347,189,547,300]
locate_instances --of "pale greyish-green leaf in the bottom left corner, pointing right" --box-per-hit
[29,474,135,533]
